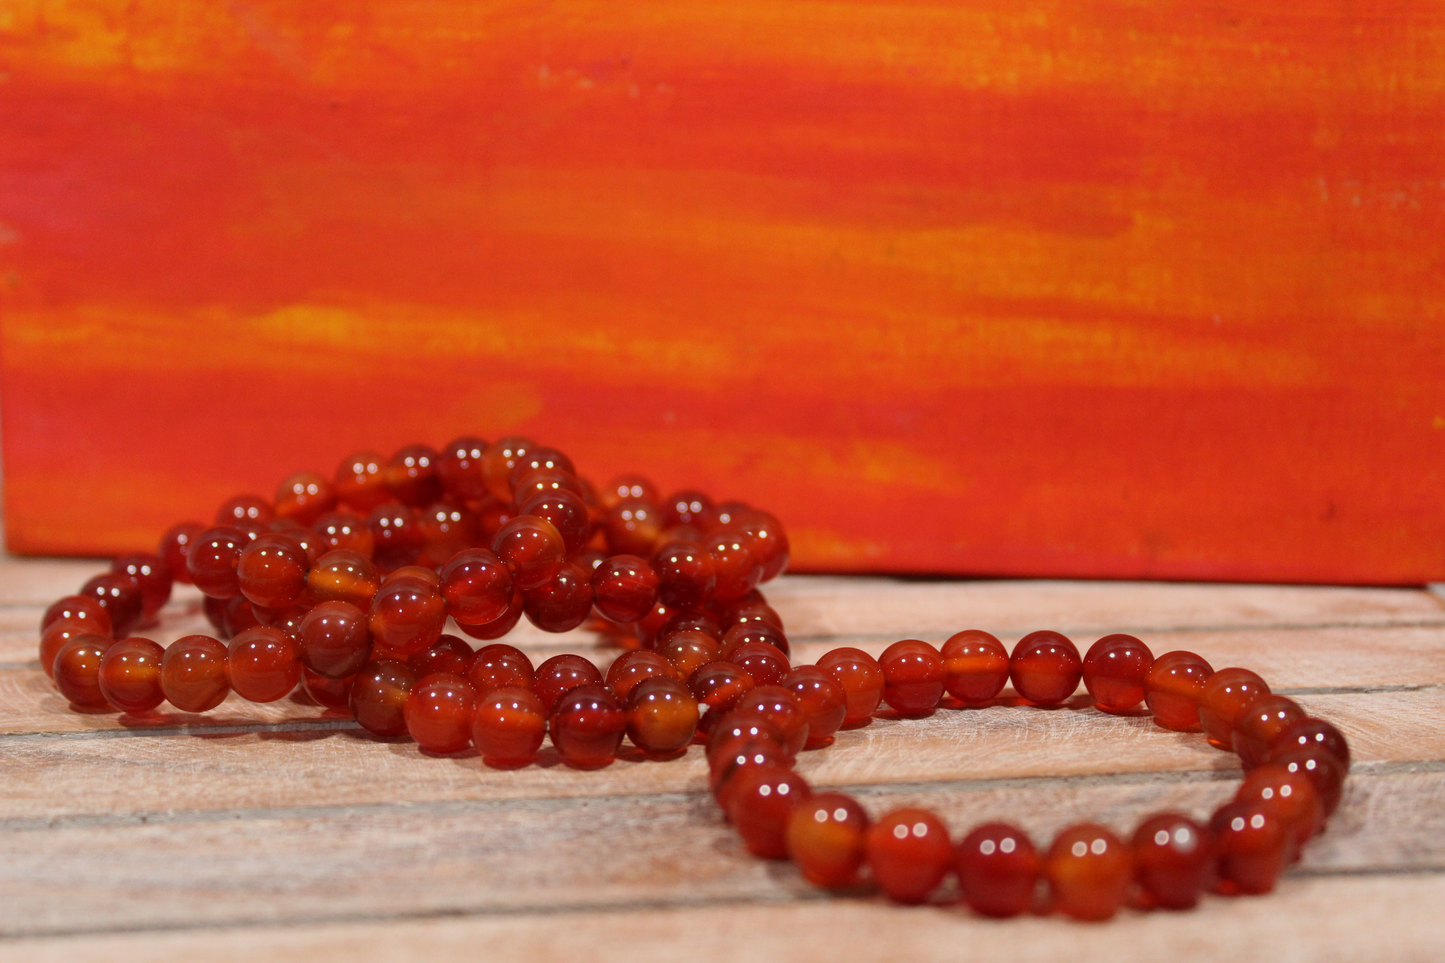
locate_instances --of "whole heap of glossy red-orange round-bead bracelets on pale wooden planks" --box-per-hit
[40,437,1350,920]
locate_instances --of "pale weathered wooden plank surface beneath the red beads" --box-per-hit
[0,558,1445,963]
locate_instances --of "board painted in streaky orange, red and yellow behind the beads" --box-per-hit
[0,0,1445,583]
